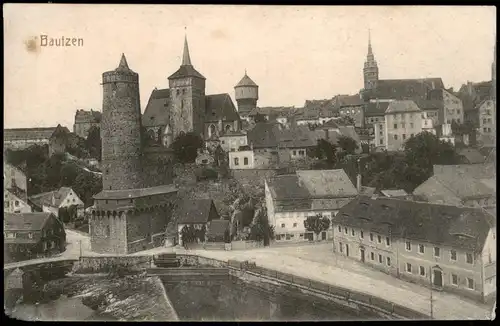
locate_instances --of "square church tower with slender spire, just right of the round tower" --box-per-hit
[168,36,205,139]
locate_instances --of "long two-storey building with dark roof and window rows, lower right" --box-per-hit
[334,196,496,301]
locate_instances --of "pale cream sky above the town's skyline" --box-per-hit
[4,4,496,130]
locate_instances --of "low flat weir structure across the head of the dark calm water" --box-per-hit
[146,267,230,283]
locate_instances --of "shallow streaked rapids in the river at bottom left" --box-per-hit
[6,275,178,321]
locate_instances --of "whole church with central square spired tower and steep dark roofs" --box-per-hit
[142,37,241,146]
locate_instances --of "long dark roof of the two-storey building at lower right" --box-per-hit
[336,197,496,253]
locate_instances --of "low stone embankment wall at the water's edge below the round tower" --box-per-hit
[72,256,152,274]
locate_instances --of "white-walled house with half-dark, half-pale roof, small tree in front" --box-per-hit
[265,170,358,241]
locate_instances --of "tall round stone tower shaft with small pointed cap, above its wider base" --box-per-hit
[101,54,142,191]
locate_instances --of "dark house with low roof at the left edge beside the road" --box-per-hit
[4,213,66,262]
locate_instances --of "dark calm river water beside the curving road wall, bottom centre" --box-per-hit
[163,280,377,321]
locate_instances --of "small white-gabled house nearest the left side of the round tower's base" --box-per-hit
[29,187,84,217]
